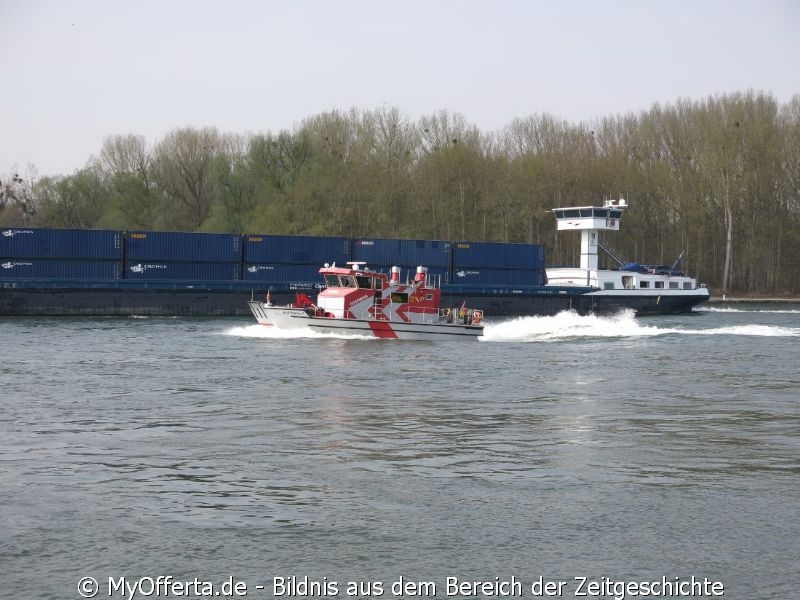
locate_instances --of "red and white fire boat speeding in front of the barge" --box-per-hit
[248,263,483,340]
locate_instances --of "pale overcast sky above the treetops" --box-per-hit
[0,0,800,175]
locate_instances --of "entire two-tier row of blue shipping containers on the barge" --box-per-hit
[0,228,545,289]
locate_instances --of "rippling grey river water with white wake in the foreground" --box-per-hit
[0,304,800,600]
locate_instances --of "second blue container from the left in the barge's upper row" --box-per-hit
[125,231,242,262]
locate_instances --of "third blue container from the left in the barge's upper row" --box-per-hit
[244,235,350,267]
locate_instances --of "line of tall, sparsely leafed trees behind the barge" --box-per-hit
[0,91,800,294]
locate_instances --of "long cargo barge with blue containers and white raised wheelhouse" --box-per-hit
[0,203,708,317]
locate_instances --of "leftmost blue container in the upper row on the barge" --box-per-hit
[0,227,122,260]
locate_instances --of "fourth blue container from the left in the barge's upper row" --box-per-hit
[351,238,451,268]
